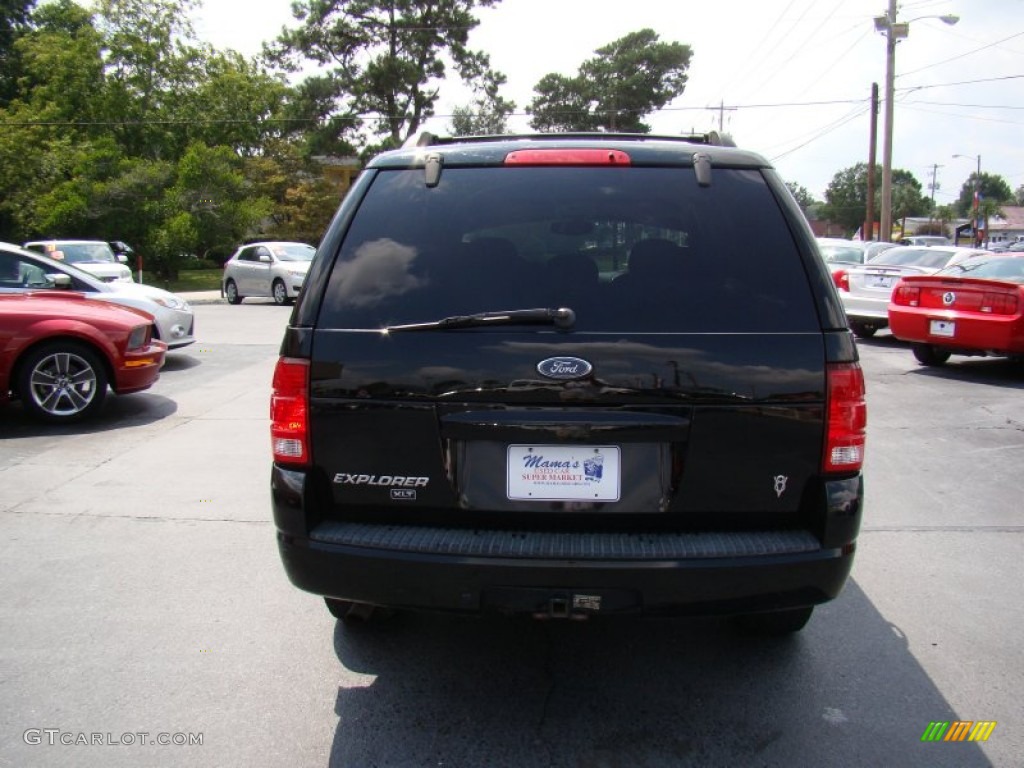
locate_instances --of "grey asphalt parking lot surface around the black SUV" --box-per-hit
[0,309,1024,768]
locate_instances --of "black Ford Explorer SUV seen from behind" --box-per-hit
[271,134,865,632]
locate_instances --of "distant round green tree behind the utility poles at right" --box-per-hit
[821,163,931,239]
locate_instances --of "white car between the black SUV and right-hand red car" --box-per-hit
[831,246,988,339]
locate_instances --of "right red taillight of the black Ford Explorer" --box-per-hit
[822,362,867,472]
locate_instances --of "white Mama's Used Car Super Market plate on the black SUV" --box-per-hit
[507,445,621,502]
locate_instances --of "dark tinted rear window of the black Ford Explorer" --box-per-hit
[319,166,820,333]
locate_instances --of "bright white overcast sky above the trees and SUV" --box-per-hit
[196,0,1024,205]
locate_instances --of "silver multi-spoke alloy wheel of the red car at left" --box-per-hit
[18,342,108,422]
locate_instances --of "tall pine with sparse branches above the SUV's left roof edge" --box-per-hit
[265,0,499,146]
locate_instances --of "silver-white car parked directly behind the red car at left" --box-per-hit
[0,243,196,349]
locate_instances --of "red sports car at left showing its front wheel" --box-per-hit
[0,291,167,423]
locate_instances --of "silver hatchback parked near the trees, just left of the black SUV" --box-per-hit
[221,242,316,304]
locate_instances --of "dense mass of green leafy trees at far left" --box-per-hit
[0,0,288,264]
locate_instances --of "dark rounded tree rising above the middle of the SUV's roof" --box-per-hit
[529,29,692,133]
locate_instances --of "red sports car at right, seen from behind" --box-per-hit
[889,254,1024,366]
